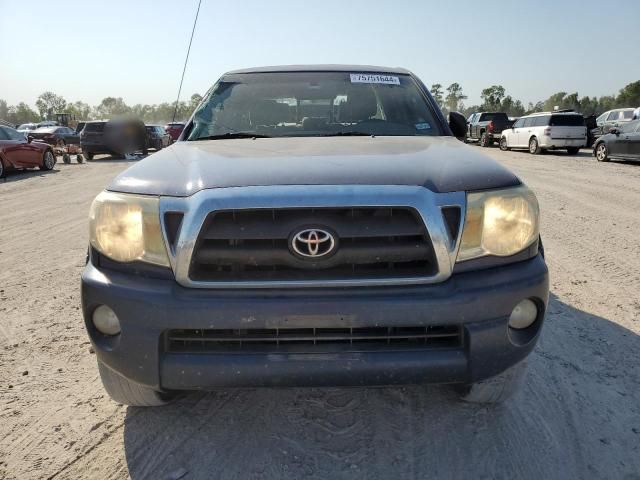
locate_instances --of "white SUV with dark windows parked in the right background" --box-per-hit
[500,112,587,155]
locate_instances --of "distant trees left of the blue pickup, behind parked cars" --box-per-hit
[0,92,202,125]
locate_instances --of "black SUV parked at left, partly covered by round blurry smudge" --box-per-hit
[80,119,148,160]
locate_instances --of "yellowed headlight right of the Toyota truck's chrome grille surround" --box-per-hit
[458,186,540,261]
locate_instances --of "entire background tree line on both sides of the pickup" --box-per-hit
[0,80,640,125]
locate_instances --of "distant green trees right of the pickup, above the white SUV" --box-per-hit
[430,80,640,117]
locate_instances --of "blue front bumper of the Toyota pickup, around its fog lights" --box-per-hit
[82,255,549,390]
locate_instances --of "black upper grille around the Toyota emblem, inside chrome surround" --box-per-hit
[189,207,437,281]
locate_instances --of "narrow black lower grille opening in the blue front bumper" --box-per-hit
[165,325,462,353]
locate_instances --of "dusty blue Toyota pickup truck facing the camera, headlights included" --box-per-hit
[81,65,549,406]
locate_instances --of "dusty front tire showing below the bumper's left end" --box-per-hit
[98,361,174,407]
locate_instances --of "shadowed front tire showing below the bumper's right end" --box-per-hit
[458,361,527,403]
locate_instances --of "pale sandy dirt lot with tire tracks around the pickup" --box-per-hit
[0,147,640,480]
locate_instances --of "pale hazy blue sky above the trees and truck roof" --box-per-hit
[0,0,640,106]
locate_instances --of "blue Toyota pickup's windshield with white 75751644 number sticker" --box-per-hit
[187,72,443,141]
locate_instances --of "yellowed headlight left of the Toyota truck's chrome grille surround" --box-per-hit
[89,192,169,266]
